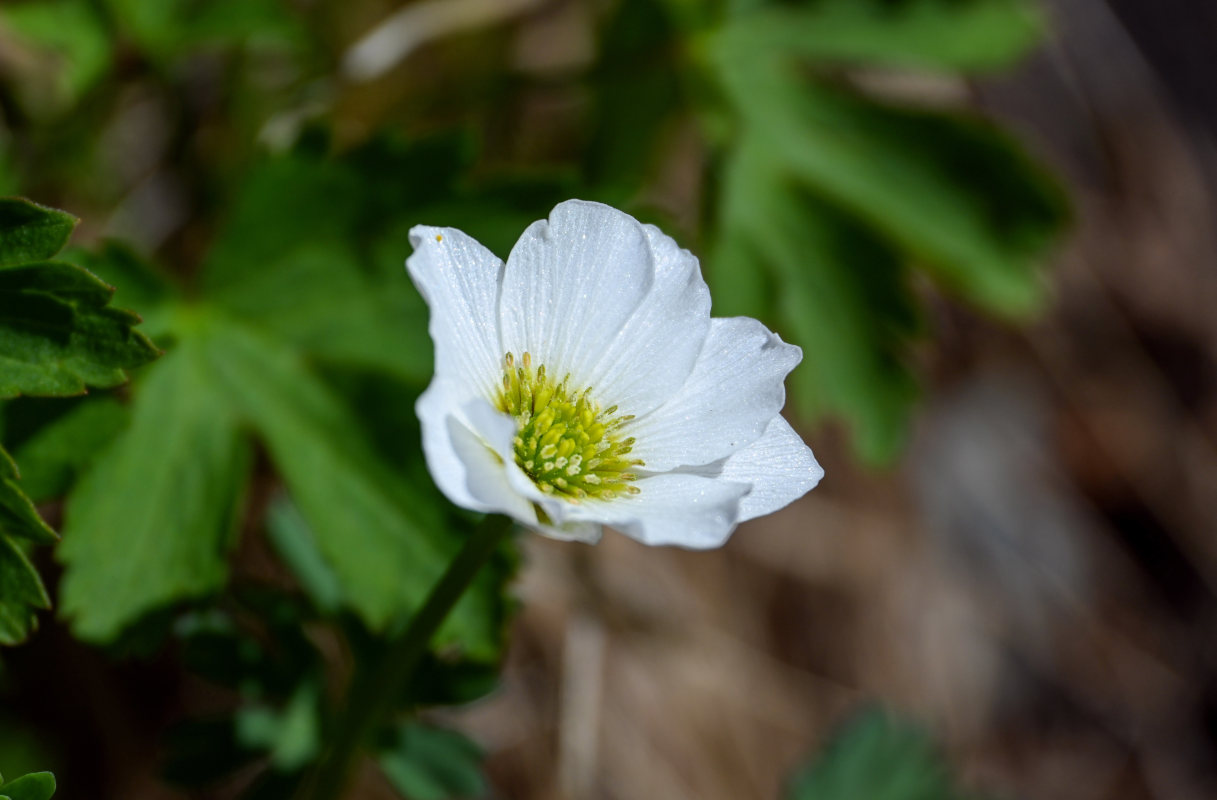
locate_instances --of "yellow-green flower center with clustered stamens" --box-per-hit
[495,353,643,500]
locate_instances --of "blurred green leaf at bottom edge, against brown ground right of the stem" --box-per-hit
[785,711,968,800]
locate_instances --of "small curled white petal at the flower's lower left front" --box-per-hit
[415,377,535,522]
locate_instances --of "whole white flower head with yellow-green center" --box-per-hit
[406,200,824,548]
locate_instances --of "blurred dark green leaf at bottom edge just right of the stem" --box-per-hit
[380,722,486,800]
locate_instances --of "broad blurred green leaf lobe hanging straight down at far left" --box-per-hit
[58,341,249,642]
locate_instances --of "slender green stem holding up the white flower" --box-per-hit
[304,515,511,800]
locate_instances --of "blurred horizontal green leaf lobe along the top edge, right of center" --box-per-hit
[717,0,1043,71]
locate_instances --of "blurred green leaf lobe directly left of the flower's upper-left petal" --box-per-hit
[204,156,431,381]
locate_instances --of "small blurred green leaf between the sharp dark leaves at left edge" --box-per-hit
[7,397,129,505]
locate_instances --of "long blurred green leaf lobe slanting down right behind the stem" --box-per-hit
[207,320,501,653]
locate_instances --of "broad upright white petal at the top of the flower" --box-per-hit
[499,200,655,401]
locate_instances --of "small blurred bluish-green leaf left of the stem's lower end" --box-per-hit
[236,682,321,772]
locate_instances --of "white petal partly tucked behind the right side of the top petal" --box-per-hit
[590,225,711,415]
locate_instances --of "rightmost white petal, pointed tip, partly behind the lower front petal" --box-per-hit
[690,416,824,522]
